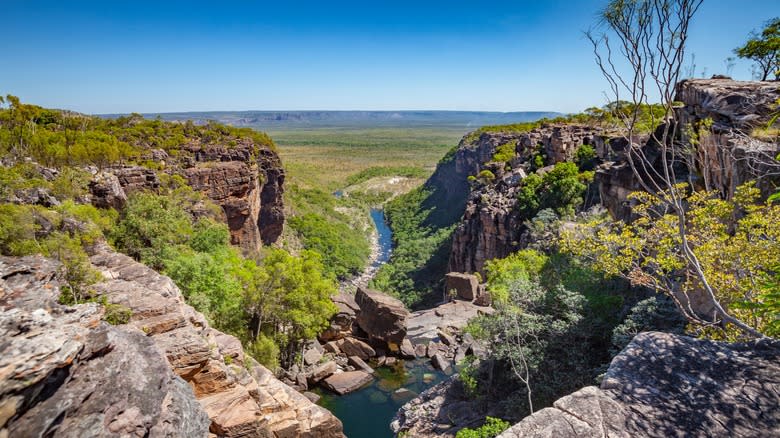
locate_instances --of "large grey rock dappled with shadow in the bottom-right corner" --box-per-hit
[500,332,780,438]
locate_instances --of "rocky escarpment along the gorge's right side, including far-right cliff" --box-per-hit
[442,79,780,273]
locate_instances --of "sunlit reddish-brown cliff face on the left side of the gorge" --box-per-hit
[90,139,285,251]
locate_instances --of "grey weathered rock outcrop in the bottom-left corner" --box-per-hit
[0,256,210,437]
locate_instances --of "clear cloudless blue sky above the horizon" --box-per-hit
[0,0,780,113]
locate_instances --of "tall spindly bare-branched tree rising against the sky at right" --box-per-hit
[587,0,762,337]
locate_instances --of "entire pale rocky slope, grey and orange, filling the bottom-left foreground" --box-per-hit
[0,244,343,437]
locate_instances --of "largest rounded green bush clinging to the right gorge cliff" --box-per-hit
[517,162,593,218]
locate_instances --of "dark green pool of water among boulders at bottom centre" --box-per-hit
[316,359,447,438]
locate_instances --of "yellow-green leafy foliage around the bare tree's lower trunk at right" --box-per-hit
[563,183,780,339]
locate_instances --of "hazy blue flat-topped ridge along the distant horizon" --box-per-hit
[104,111,561,130]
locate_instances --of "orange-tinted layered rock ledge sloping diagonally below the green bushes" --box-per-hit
[90,245,342,437]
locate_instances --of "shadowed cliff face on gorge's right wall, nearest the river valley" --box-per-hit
[448,125,607,273]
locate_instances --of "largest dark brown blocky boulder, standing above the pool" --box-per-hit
[355,287,409,351]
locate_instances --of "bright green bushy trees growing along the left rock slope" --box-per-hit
[111,193,336,367]
